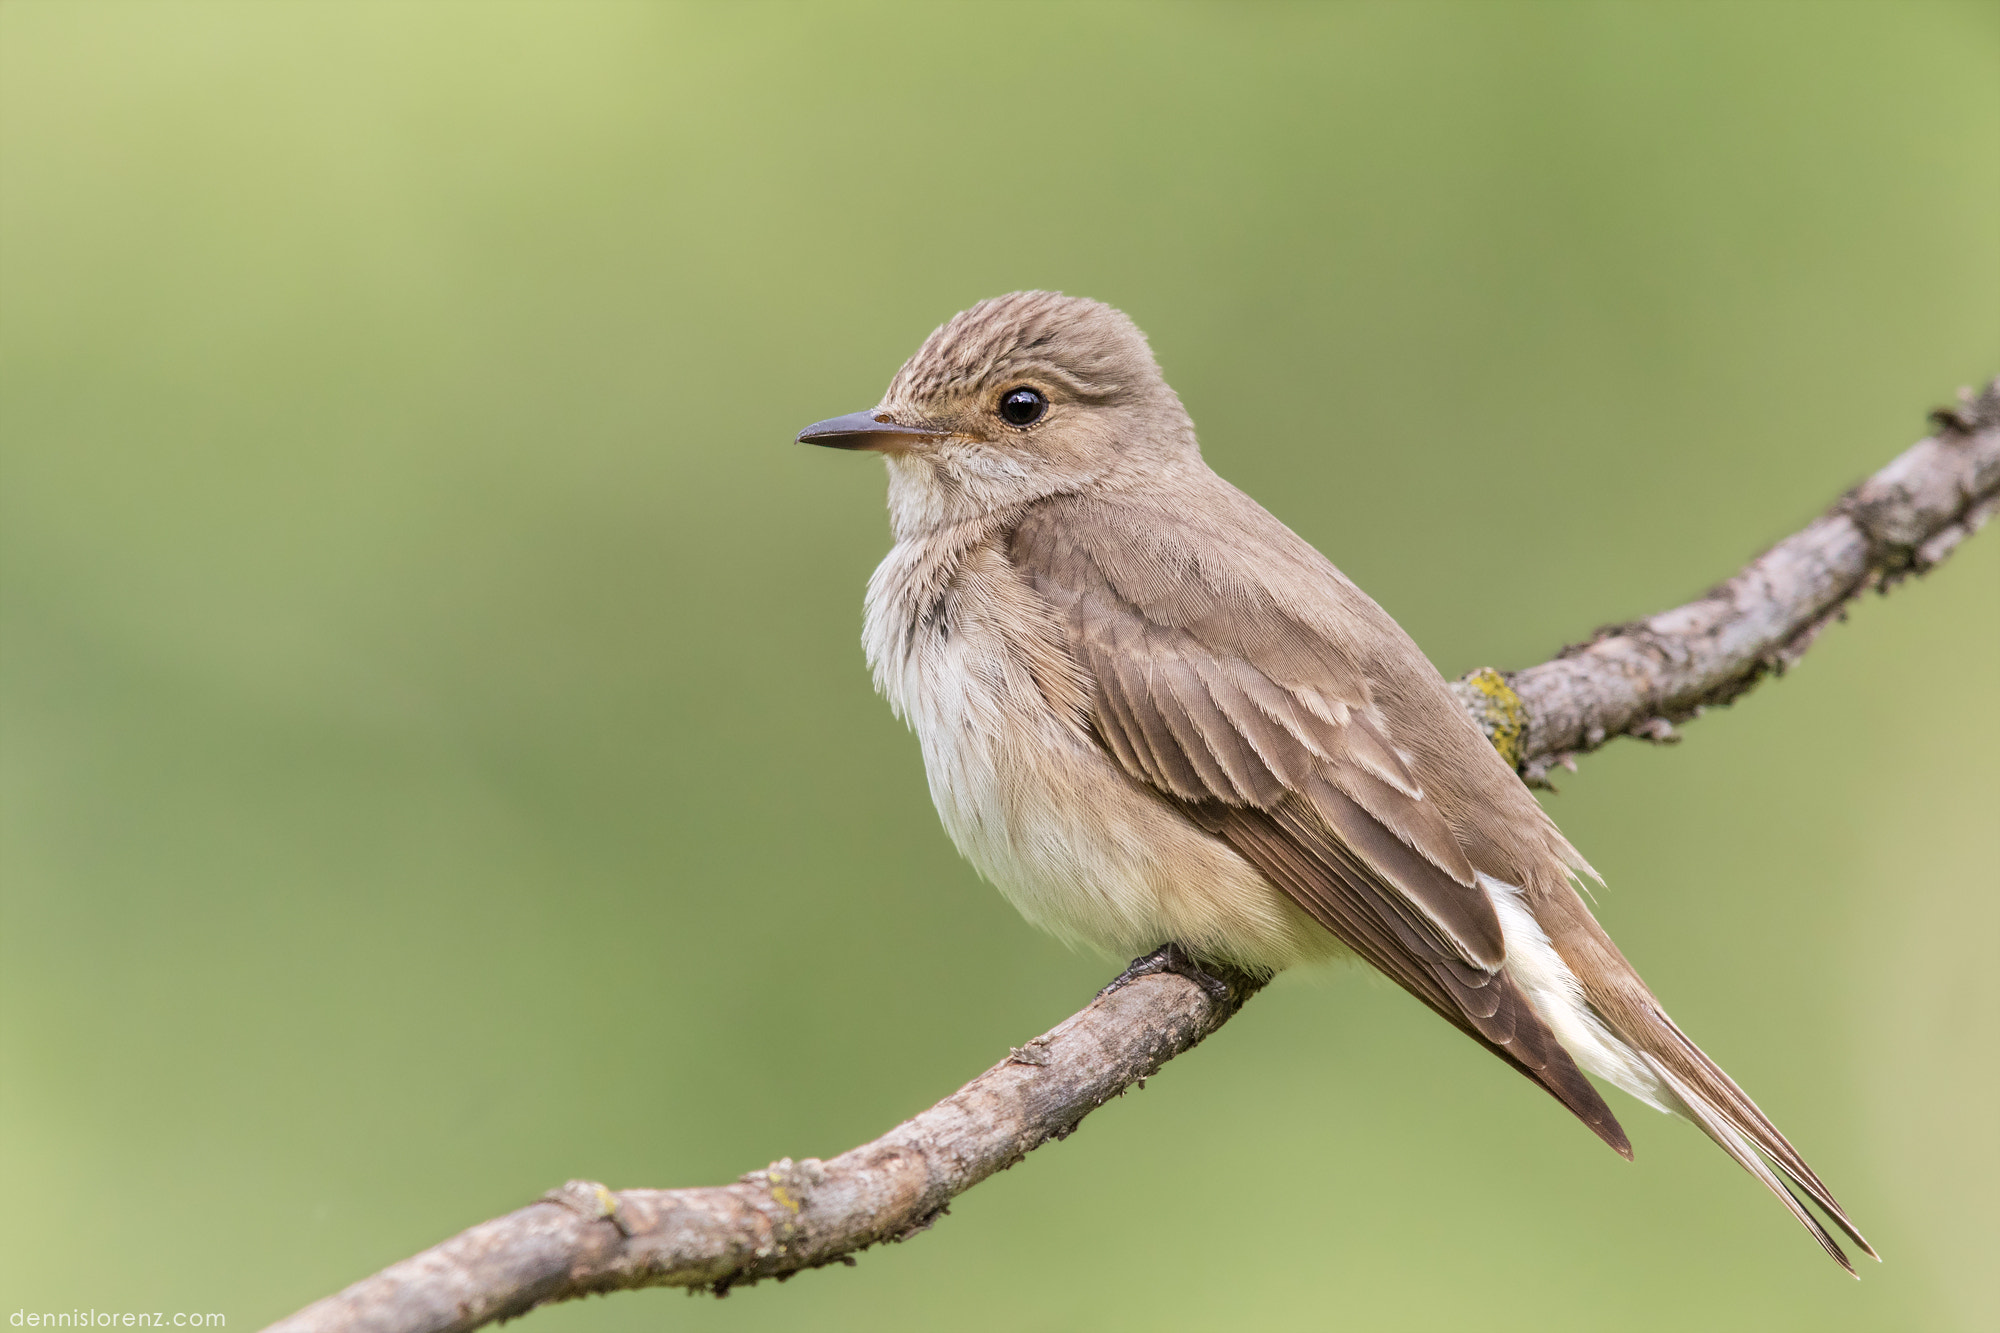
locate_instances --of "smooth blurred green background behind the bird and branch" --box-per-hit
[0,0,2000,1333]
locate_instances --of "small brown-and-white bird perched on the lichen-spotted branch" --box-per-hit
[798,290,1876,1275]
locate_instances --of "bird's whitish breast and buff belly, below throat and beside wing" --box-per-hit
[862,532,1340,969]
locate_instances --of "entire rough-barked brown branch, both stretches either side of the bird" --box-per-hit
[272,378,2000,1333]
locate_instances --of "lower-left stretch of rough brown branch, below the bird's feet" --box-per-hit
[272,960,1262,1333]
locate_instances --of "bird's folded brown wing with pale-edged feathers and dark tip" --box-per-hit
[1008,496,1632,1157]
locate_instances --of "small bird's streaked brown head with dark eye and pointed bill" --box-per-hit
[798,292,1198,534]
